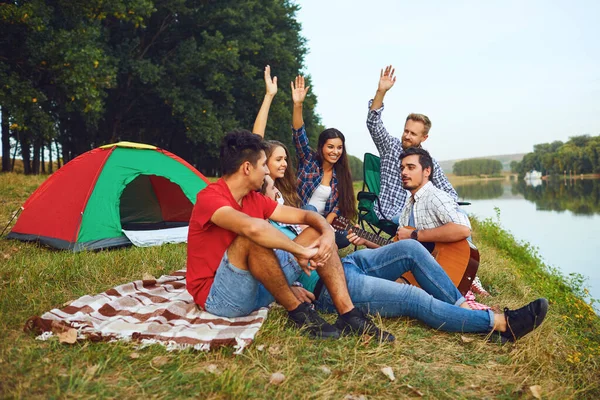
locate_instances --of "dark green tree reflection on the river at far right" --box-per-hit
[512,179,600,215]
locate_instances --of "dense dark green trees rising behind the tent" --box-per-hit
[0,0,338,176]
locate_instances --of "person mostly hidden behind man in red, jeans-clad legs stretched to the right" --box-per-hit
[262,177,548,343]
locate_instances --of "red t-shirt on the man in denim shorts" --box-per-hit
[186,179,277,307]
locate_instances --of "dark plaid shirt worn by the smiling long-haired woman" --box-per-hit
[292,125,339,216]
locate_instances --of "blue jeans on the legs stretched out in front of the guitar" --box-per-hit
[316,240,494,332]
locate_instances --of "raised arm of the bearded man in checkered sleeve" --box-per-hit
[367,65,398,156]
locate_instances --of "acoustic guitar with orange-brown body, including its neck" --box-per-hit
[331,217,479,295]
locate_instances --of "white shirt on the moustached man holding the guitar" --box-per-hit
[400,182,471,229]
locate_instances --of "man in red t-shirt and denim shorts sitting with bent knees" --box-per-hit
[186,131,394,341]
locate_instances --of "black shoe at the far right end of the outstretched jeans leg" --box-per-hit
[491,298,548,343]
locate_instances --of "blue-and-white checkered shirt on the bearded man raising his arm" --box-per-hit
[367,100,458,219]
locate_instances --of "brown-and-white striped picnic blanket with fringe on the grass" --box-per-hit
[25,270,268,354]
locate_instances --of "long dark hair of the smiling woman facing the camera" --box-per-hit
[317,128,356,220]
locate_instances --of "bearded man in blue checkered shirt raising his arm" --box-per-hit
[367,65,458,220]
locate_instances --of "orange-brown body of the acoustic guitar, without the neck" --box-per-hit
[402,239,479,296]
